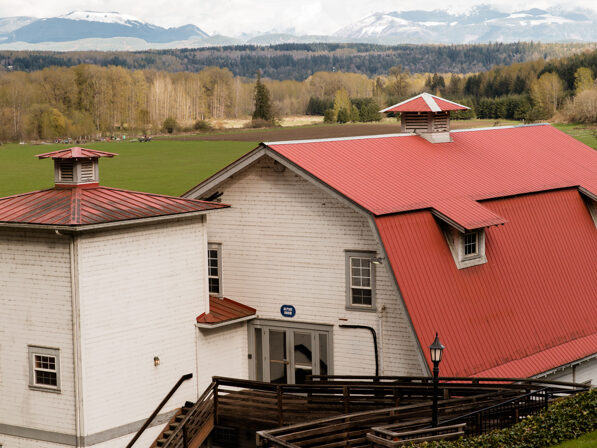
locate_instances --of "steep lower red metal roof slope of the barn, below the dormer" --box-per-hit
[376,189,597,376]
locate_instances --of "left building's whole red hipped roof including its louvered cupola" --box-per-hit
[0,147,228,229]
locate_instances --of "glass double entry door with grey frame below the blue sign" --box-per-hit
[249,320,332,384]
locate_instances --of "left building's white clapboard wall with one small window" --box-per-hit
[0,230,75,434]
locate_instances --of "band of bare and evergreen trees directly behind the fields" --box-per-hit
[0,43,597,141]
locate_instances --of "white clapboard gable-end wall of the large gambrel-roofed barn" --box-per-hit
[203,158,423,375]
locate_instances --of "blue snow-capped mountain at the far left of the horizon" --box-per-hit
[0,11,209,43]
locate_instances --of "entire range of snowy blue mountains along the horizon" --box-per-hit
[0,5,597,51]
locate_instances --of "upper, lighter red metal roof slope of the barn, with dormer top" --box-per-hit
[267,125,597,222]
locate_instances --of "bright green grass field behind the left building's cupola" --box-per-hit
[0,141,256,197]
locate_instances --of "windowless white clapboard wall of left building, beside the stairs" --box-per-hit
[79,219,207,435]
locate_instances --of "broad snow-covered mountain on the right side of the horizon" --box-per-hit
[334,5,597,43]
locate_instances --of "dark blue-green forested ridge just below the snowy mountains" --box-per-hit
[0,41,597,80]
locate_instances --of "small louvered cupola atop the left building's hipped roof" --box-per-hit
[37,147,118,188]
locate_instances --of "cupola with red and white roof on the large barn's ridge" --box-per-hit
[380,93,469,143]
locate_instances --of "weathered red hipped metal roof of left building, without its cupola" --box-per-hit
[0,184,228,226]
